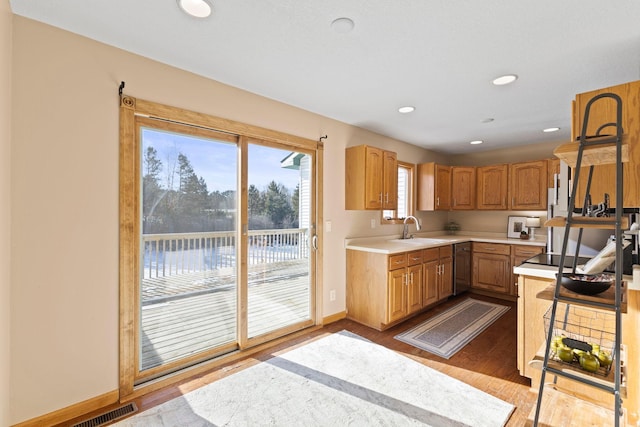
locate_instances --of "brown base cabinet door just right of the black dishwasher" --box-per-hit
[472,252,511,294]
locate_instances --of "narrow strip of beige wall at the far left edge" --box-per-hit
[0,0,13,426]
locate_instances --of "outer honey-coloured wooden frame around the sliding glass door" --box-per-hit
[118,95,323,402]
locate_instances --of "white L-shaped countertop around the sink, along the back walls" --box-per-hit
[345,233,547,254]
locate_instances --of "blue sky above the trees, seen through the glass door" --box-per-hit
[142,128,299,192]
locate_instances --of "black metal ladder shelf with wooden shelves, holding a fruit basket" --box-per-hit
[530,93,629,427]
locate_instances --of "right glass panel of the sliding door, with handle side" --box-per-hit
[247,144,315,340]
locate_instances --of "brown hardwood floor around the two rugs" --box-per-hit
[60,294,536,427]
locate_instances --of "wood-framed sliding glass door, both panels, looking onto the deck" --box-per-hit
[129,117,316,384]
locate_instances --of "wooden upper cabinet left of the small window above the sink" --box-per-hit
[345,145,398,210]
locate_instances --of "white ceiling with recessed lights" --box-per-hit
[11,0,640,153]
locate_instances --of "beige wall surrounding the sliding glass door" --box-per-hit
[10,16,444,423]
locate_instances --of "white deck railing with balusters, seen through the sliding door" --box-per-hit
[142,228,309,279]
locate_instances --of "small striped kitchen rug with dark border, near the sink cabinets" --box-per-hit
[395,298,509,359]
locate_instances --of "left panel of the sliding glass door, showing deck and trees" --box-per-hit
[137,120,239,380]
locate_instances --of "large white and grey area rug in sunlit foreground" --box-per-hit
[115,331,514,427]
